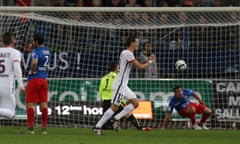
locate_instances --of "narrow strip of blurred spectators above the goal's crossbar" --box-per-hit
[0,0,240,7]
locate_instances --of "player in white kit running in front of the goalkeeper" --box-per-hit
[93,36,155,135]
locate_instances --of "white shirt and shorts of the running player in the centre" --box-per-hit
[112,50,136,105]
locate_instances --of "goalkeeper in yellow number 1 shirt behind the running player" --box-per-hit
[99,62,151,131]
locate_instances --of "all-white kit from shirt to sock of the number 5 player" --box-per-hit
[0,47,21,118]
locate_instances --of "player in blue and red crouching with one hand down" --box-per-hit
[161,85,212,130]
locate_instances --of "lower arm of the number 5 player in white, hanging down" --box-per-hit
[13,61,24,91]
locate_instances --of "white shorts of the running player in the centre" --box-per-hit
[111,86,137,105]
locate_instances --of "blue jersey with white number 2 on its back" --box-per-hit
[28,47,50,80]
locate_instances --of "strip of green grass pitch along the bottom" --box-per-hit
[0,127,240,144]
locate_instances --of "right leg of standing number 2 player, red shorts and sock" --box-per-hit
[38,79,48,134]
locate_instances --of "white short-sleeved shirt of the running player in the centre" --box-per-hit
[113,50,136,88]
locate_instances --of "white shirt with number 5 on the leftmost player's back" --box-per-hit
[0,47,21,78]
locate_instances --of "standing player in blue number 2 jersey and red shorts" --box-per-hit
[26,34,50,134]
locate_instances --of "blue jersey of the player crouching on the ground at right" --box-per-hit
[167,89,193,112]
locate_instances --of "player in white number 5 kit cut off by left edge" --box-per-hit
[0,32,24,118]
